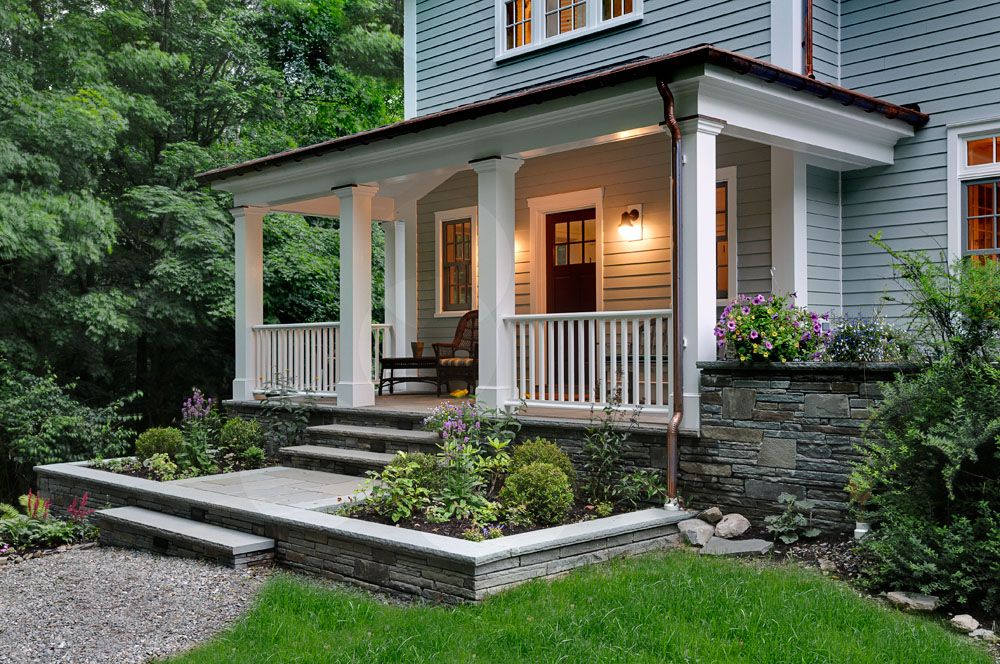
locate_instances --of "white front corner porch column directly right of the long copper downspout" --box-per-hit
[680,116,725,431]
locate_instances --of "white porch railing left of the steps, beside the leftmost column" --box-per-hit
[253,322,393,396]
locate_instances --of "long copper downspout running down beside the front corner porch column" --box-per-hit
[656,78,684,506]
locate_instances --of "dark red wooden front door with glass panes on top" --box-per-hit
[548,208,597,314]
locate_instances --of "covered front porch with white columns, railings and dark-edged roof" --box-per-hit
[203,49,913,432]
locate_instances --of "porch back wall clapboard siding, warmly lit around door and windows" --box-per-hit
[417,134,771,343]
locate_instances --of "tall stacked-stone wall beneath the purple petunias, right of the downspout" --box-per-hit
[680,362,911,530]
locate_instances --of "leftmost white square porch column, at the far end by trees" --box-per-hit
[230,207,268,400]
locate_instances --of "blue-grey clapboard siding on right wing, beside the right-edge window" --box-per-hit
[841,0,1000,317]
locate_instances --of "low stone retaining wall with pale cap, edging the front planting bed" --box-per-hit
[36,463,690,603]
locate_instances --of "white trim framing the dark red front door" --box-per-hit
[528,187,604,314]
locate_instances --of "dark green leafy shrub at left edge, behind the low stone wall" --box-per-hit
[0,364,137,500]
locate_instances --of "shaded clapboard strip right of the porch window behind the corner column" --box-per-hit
[716,136,772,294]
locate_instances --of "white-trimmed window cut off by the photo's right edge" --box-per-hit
[948,120,1000,260]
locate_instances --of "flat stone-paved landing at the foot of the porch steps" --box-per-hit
[170,466,365,510]
